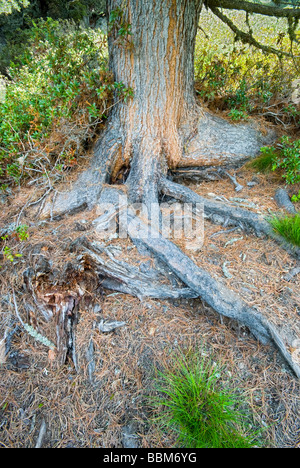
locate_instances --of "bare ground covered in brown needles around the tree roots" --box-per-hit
[0,162,300,448]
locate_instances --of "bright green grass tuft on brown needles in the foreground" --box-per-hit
[151,352,260,448]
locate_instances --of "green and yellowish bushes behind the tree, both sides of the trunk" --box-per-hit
[0,1,300,190]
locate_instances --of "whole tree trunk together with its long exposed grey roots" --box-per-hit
[32,0,300,376]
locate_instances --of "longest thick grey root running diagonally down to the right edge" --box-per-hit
[85,185,300,378]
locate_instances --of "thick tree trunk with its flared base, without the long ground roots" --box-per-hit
[42,0,271,217]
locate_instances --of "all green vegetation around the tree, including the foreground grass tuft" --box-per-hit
[0,0,300,448]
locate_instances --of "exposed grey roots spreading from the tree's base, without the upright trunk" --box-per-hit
[30,111,300,377]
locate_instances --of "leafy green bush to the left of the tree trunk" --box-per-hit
[0,18,132,183]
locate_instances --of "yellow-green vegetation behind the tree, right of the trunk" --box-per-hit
[195,11,300,126]
